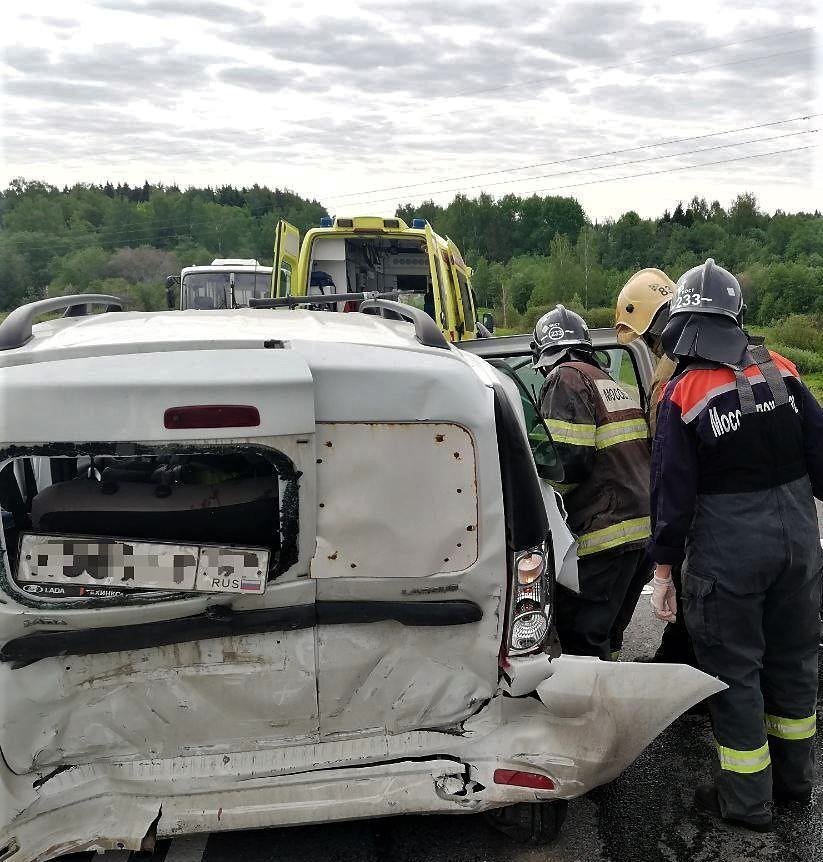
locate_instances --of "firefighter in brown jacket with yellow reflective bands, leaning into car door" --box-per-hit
[532,305,649,660]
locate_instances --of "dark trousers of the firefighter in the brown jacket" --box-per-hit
[556,548,645,661]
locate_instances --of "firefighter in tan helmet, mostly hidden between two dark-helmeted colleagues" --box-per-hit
[612,268,695,665]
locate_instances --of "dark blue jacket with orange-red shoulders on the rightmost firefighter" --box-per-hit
[648,352,823,563]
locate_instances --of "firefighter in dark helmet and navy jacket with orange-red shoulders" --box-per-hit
[649,260,823,831]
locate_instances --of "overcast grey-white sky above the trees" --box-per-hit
[0,0,823,220]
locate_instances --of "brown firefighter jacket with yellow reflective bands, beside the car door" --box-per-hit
[540,362,650,557]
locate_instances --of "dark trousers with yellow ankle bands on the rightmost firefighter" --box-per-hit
[683,479,821,823]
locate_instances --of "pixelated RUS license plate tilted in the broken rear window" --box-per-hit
[16,533,269,598]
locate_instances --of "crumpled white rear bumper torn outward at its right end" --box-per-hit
[0,657,723,862]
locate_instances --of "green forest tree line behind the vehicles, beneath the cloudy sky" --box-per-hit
[0,179,823,336]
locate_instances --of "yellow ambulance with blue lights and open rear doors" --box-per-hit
[272,216,488,342]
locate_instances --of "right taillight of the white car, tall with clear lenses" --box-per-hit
[508,545,551,655]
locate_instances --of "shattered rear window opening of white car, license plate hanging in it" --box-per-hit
[0,444,297,600]
